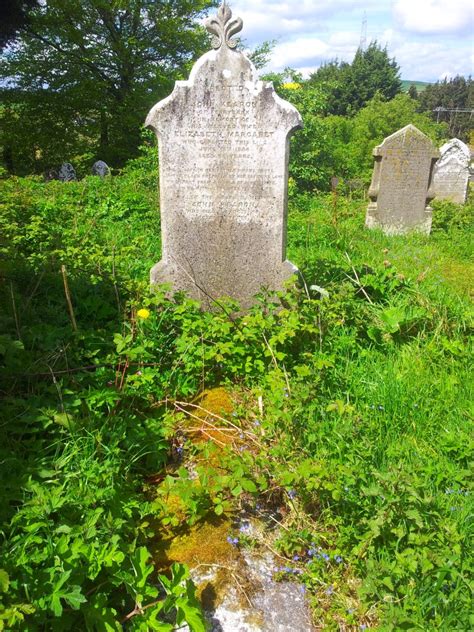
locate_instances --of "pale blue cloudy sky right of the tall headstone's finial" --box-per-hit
[219,0,474,82]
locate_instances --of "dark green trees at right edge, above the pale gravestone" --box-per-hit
[420,75,474,141]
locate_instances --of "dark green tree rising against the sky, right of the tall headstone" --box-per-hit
[310,41,401,116]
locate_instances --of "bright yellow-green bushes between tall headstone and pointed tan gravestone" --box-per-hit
[276,80,448,191]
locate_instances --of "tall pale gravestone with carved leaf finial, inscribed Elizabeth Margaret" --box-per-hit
[146,3,302,308]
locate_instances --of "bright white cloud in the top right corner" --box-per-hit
[393,0,474,34]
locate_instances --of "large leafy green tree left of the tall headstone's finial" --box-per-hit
[2,0,216,172]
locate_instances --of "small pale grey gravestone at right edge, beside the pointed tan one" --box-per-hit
[433,138,471,204]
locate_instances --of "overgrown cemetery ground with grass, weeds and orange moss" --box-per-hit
[0,155,474,630]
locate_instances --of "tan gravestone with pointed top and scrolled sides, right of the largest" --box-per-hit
[365,125,439,235]
